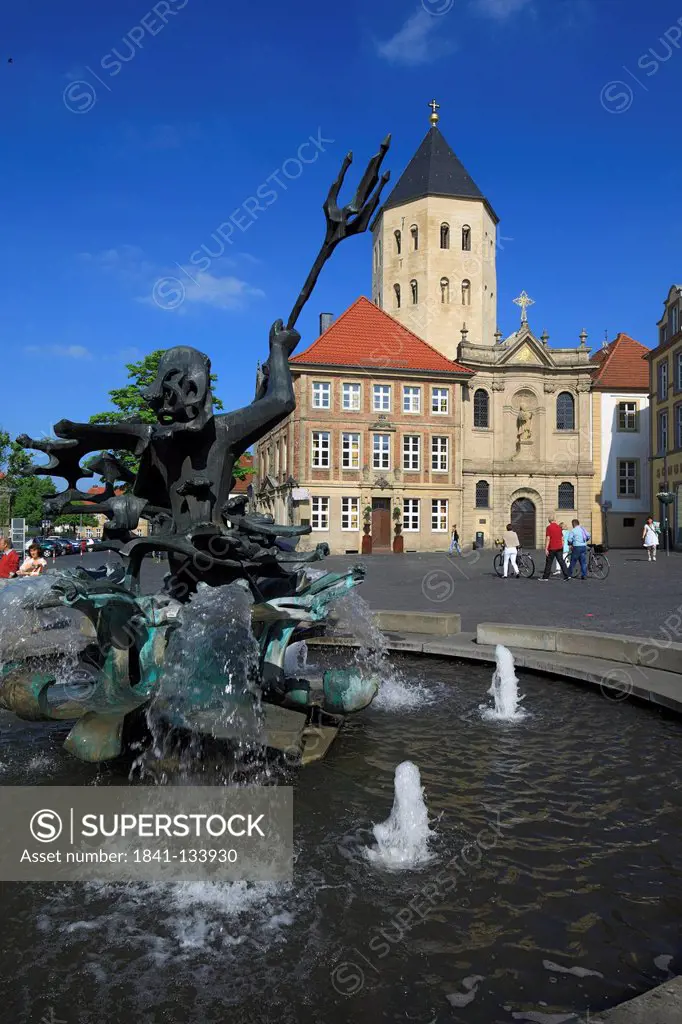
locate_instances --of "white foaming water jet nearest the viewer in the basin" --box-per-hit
[365,761,435,870]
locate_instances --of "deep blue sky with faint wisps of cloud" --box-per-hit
[0,0,682,435]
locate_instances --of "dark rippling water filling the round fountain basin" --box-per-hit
[0,658,682,1024]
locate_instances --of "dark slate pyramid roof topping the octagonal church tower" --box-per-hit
[383,124,499,222]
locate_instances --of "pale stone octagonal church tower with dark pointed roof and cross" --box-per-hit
[372,100,499,359]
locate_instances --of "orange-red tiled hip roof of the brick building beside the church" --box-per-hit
[291,295,472,374]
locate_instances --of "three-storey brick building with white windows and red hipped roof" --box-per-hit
[251,297,471,553]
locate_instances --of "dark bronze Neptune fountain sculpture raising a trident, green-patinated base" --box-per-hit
[0,137,389,763]
